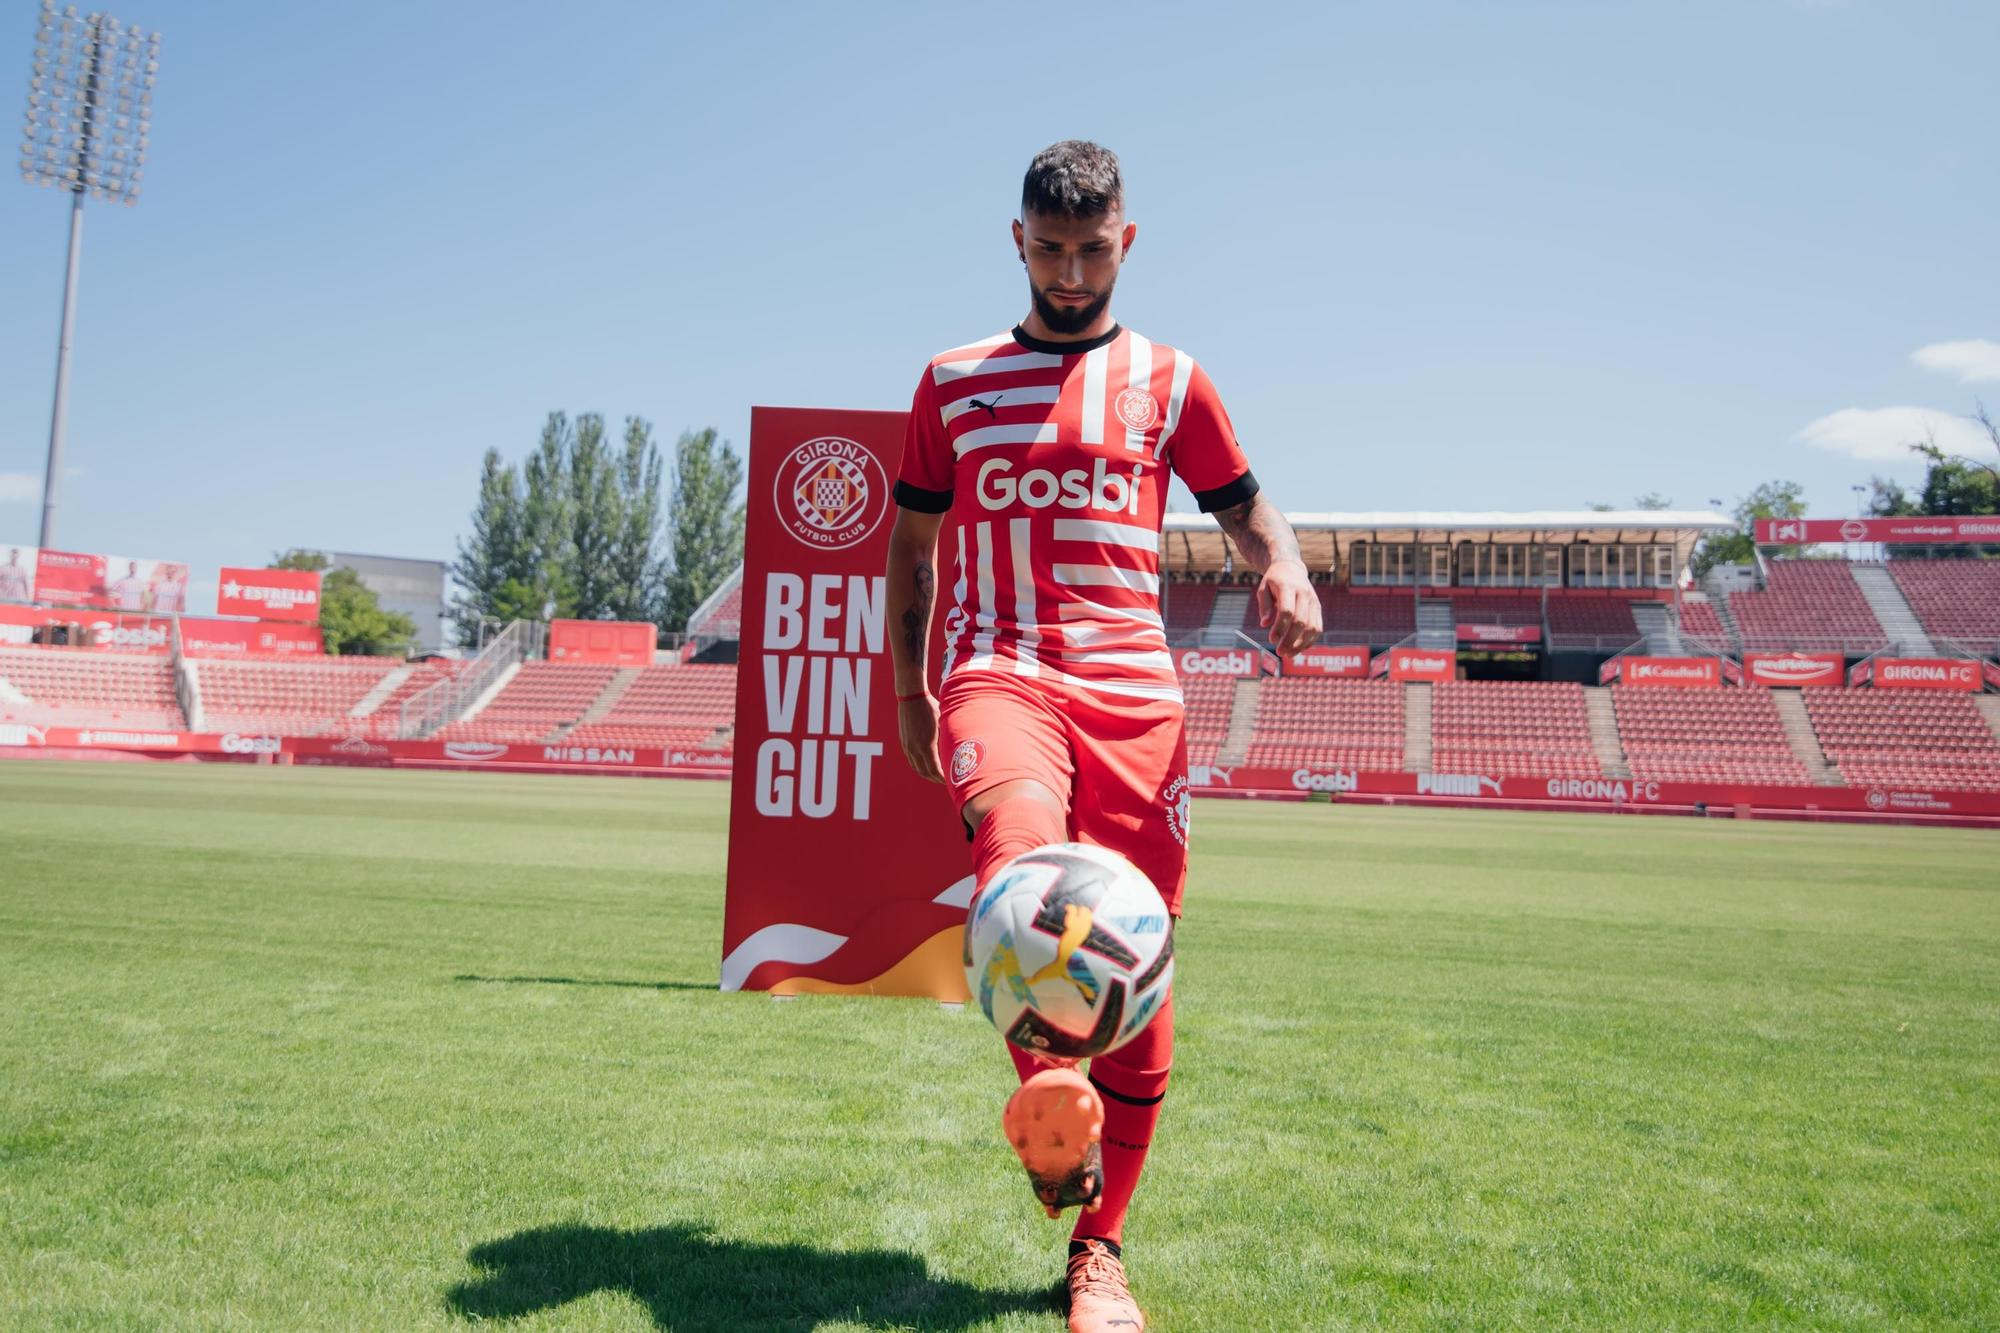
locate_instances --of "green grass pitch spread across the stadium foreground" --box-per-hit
[0,763,2000,1333]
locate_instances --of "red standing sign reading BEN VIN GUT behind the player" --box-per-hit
[722,408,972,1001]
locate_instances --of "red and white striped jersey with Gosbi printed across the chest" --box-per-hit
[896,328,1258,701]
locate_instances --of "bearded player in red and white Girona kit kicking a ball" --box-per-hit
[886,140,1320,1333]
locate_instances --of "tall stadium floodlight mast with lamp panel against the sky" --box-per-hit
[20,0,160,546]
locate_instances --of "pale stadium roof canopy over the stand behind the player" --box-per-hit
[1164,508,1736,572]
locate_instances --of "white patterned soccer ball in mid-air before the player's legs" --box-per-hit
[966,843,1174,1059]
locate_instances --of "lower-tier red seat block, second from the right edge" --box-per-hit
[1612,687,1812,785]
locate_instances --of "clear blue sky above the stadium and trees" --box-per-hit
[0,0,2000,608]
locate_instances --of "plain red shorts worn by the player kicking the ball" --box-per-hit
[938,671,1188,917]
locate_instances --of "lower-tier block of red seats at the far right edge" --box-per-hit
[1800,691,2000,791]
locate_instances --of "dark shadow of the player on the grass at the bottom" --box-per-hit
[446,1225,1060,1333]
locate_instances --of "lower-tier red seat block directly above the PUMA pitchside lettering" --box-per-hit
[1430,681,1602,777]
